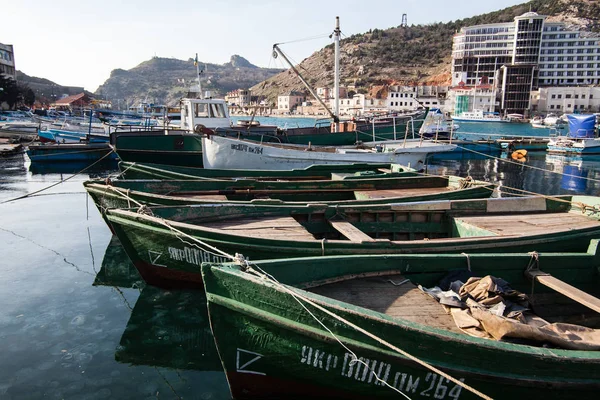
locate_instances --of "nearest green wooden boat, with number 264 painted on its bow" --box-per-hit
[202,245,600,400]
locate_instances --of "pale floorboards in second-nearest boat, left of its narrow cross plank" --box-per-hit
[201,216,315,241]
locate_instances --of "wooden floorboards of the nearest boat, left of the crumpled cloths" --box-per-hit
[308,275,461,333]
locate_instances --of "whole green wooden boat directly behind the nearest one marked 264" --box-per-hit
[106,196,600,287]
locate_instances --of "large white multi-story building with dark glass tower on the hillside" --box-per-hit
[452,12,600,114]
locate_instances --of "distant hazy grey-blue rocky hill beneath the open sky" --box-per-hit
[96,55,281,105]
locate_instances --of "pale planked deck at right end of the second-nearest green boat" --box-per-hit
[455,213,600,235]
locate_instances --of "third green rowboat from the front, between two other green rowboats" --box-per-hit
[83,173,494,222]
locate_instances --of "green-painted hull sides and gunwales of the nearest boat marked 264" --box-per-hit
[202,245,600,399]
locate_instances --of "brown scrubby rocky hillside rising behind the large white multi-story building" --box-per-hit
[252,0,600,101]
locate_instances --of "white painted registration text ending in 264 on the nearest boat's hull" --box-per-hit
[300,346,464,400]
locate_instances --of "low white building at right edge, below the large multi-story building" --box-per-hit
[535,86,600,114]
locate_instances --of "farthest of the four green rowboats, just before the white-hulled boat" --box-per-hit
[119,161,417,180]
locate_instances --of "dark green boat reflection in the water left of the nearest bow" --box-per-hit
[94,237,223,372]
